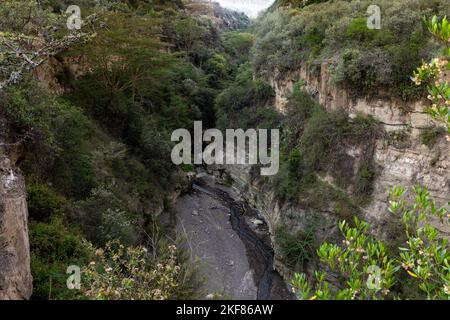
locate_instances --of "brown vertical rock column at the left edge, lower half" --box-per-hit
[0,115,32,300]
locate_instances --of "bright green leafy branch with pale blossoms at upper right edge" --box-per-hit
[412,16,450,133]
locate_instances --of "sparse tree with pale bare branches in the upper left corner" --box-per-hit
[0,0,95,91]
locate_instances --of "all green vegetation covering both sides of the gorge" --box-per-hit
[0,0,450,299]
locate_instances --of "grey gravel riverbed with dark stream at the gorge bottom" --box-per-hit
[175,174,292,300]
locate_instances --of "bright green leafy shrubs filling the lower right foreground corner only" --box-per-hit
[292,186,450,299]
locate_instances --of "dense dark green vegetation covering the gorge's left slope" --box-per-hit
[0,0,253,299]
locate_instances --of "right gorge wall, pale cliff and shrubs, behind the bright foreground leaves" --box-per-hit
[213,1,450,296]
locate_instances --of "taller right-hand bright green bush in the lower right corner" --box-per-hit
[389,186,450,299]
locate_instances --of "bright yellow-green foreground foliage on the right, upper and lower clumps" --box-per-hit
[281,10,450,300]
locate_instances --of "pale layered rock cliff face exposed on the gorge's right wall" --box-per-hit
[213,64,450,276]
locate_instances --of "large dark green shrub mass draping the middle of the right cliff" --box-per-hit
[272,90,379,210]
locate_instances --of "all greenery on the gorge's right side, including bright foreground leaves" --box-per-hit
[216,1,450,299]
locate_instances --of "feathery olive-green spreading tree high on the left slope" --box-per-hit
[71,13,175,99]
